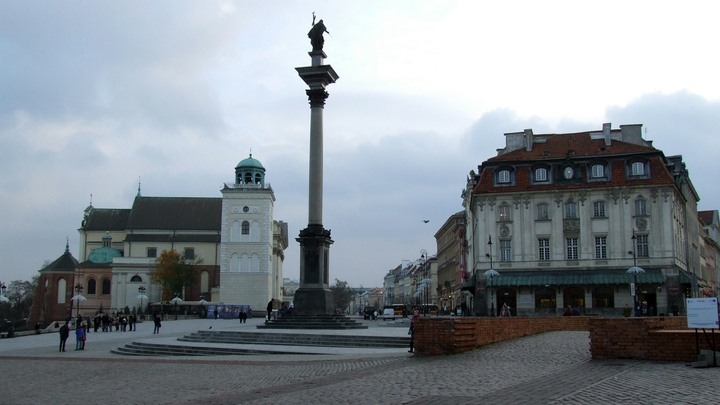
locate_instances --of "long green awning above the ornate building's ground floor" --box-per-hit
[488,269,665,287]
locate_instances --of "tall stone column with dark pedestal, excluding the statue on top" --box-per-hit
[294,50,338,315]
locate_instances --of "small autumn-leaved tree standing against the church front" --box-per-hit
[150,250,202,301]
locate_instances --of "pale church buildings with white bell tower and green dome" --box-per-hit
[34,156,288,322]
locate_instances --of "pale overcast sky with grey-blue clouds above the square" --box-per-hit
[0,0,720,287]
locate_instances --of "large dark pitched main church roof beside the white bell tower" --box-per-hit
[126,197,222,231]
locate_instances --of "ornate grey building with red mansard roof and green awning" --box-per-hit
[463,124,717,316]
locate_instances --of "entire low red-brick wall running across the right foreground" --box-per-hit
[414,316,720,362]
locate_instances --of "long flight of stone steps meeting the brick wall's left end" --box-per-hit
[178,330,410,348]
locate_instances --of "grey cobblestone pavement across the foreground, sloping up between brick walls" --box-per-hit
[0,332,720,405]
